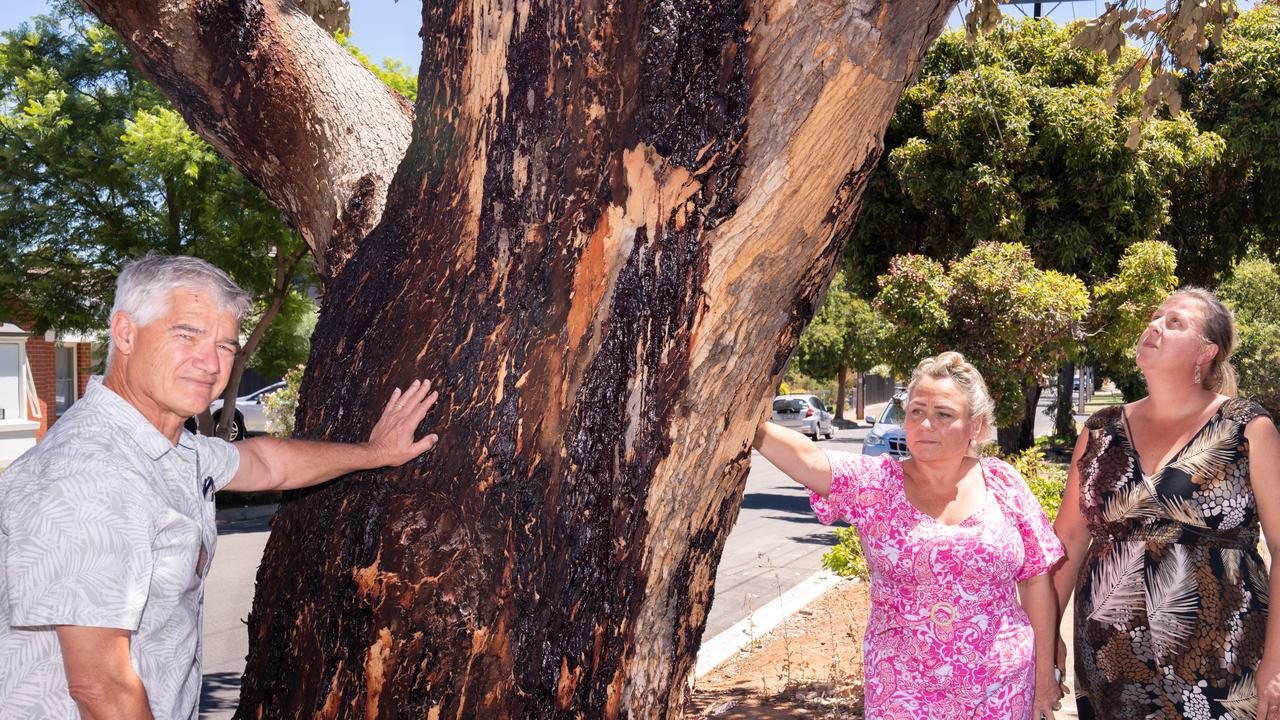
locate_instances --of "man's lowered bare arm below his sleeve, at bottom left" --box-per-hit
[58,625,152,720]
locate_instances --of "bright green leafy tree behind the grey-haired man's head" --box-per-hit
[0,3,315,376]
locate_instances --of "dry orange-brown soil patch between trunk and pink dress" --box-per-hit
[685,580,869,720]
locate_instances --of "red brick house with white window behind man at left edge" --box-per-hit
[0,320,101,466]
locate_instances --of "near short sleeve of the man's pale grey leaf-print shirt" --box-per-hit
[4,456,155,630]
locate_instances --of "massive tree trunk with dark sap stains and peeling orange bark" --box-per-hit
[88,0,951,719]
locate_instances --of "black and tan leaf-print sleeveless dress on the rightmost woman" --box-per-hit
[1075,398,1268,720]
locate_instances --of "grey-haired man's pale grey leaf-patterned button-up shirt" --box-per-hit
[0,378,239,720]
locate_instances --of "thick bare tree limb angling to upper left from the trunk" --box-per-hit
[82,0,413,277]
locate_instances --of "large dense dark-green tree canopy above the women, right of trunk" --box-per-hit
[846,19,1224,293]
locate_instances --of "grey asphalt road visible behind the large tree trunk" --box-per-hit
[200,400,1051,720]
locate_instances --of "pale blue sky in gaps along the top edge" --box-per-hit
[0,0,1254,69]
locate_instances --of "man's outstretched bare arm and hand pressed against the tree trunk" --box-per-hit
[227,380,436,492]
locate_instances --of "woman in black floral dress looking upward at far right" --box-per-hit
[1053,288,1280,720]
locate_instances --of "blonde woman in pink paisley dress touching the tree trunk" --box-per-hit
[755,352,1062,720]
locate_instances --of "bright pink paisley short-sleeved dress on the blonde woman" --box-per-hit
[812,452,1062,720]
